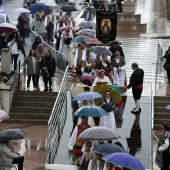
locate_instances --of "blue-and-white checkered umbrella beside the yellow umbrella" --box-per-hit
[73,92,102,101]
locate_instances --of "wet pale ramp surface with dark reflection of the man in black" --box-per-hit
[115,96,152,169]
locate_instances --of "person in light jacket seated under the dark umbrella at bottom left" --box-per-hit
[0,140,24,170]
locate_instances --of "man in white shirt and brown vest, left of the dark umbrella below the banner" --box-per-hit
[74,42,89,76]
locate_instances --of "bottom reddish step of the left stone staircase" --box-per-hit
[3,118,48,125]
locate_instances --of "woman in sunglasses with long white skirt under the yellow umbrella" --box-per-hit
[99,91,117,130]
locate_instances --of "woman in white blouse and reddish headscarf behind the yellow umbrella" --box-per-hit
[92,69,110,86]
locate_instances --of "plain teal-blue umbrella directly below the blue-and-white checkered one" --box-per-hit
[74,106,109,117]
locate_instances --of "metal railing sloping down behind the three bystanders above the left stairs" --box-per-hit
[30,31,66,73]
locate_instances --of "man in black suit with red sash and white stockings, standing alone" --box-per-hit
[127,63,144,114]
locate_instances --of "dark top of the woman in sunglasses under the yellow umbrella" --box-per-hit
[99,98,115,113]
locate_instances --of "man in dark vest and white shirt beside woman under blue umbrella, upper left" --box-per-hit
[47,9,54,43]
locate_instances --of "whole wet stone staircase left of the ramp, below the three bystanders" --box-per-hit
[4,91,58,124]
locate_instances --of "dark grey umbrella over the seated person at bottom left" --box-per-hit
[0,129,27,141]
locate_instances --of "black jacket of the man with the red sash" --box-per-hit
[127,68,144,89]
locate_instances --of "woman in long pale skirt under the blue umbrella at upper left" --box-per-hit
[35,7,46,34]
